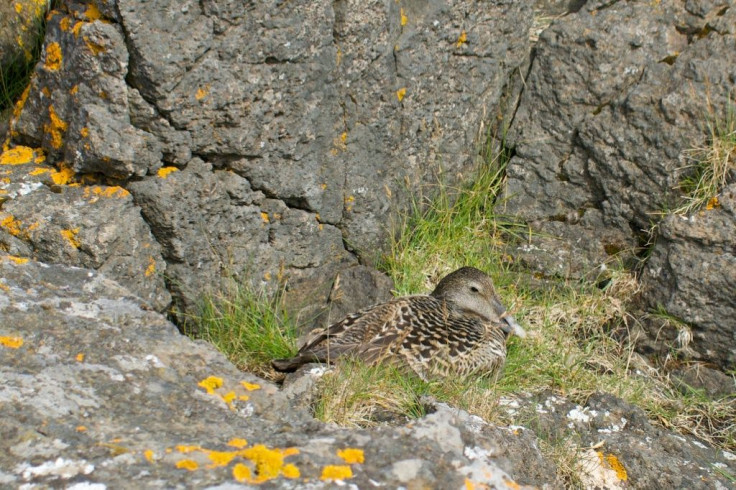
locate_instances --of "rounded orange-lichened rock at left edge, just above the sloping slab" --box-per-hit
[0,147,171,311]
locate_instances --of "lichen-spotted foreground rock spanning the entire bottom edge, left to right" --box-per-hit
[0,254,736,489]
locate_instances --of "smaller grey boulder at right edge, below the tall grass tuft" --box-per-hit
[642,184,736,369]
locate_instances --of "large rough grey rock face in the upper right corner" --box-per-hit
[500,2,736,276]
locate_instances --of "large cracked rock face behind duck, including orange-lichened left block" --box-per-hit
[4,0,533,318]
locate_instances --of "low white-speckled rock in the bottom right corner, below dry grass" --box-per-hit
[502,393,736,490]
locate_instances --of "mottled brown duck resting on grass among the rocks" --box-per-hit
[272,267,526,380]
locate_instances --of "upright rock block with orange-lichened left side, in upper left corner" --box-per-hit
[14,4,161,179]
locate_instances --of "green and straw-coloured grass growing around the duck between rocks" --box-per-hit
[188,126,736,487]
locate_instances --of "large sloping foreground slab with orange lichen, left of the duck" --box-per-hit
[0,255,536,489]
